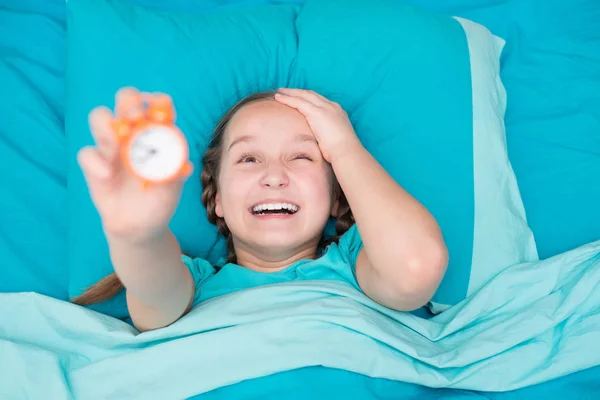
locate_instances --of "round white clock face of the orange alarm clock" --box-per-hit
[127,125,186,181]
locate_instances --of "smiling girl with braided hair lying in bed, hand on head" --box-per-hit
[75,88,448,331]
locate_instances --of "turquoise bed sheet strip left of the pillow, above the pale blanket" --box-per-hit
[0,0,68,299]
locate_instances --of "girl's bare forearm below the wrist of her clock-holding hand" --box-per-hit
[107,231,195,331]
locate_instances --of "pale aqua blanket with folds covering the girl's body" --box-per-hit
[0,241,600,399]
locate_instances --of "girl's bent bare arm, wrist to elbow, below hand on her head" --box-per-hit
[331,141,448,311]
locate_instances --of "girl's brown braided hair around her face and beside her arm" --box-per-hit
[73,92,354,305]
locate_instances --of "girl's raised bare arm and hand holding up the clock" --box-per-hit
[78,88,195,331]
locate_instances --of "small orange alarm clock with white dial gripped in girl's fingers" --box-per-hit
[113,92,193,188]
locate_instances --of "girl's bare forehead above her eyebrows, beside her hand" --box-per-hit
[227,99,313,142]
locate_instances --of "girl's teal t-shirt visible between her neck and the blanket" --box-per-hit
[183,224,363,305]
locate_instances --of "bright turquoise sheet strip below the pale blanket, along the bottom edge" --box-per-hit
[199,367,600,400]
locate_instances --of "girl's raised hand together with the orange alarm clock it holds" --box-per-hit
[78,88,192,242]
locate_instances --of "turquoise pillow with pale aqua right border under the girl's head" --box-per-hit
[66,0,537,315]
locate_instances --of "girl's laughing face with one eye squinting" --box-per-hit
[215,100,334,261]
